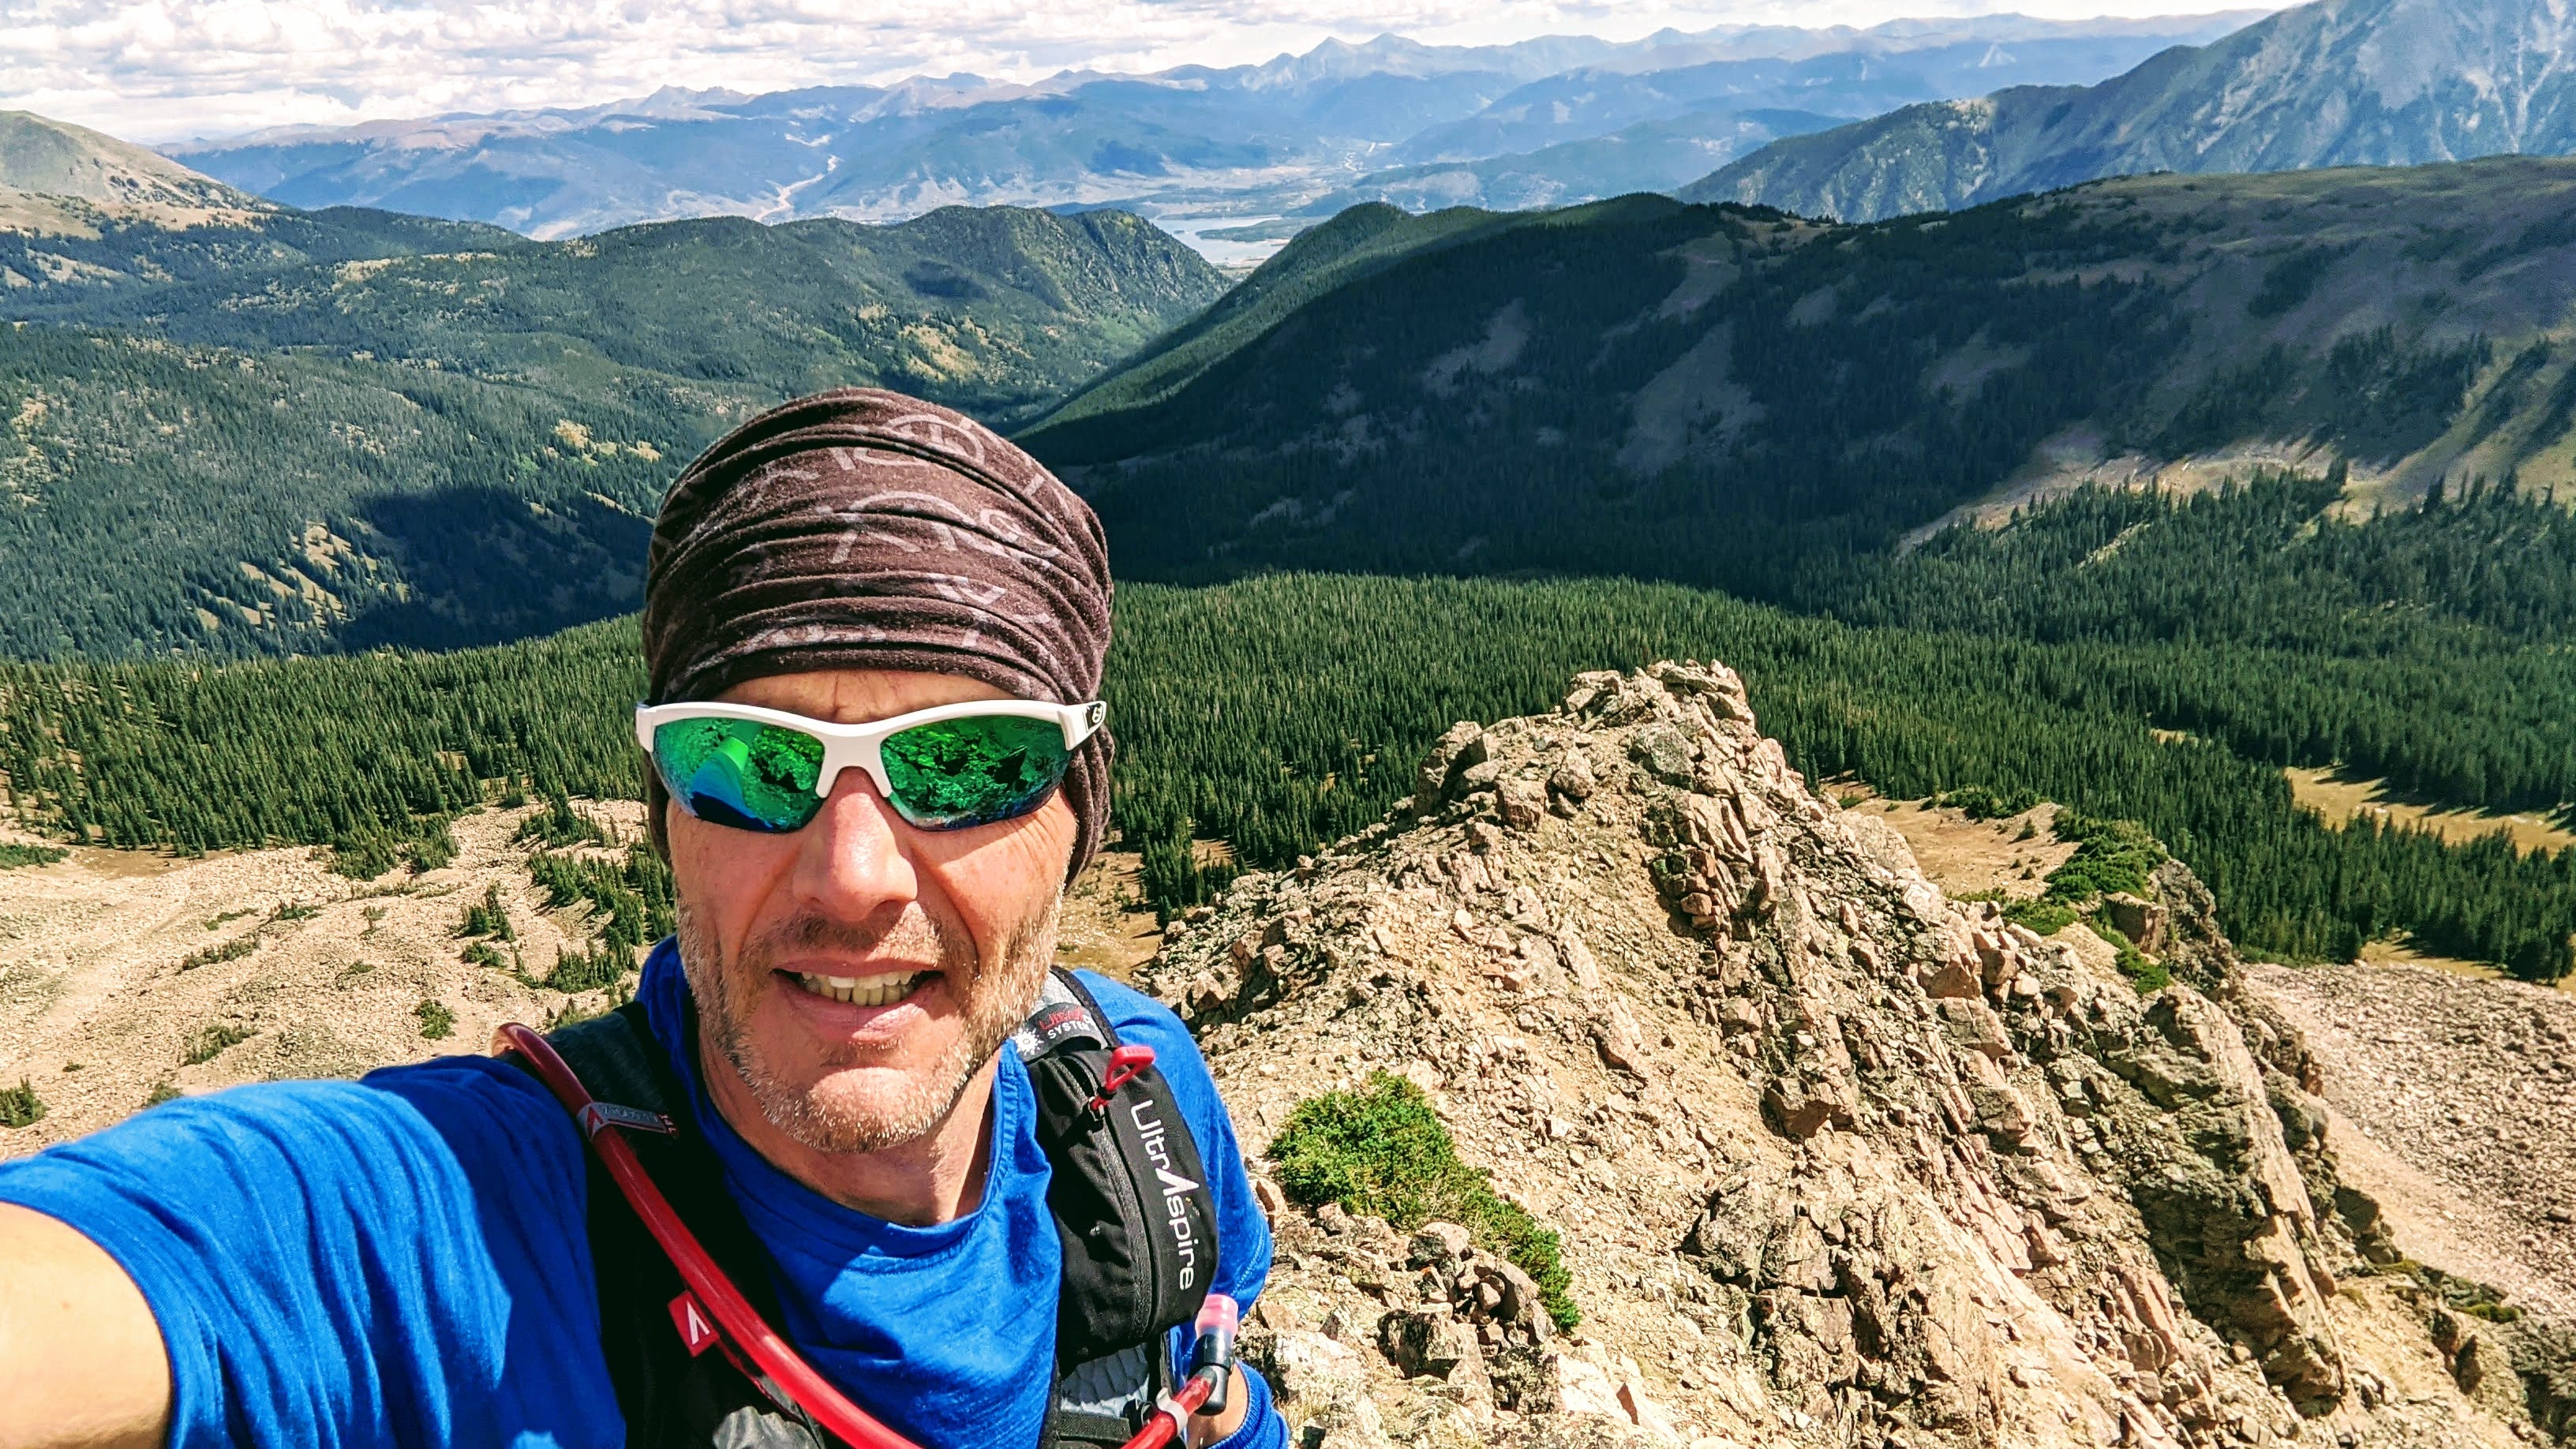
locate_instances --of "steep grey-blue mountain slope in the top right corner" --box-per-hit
[1682,0,2576,219]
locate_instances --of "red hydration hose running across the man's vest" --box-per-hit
[492,1021,1234,1449]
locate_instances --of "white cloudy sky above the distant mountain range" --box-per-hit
[0,0,2262,142]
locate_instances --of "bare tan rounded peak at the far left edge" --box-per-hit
[0,110,275,232]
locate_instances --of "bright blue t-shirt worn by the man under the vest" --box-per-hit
[0,941,1286,1449]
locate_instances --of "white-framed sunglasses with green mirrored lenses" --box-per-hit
[636,698,1108,833]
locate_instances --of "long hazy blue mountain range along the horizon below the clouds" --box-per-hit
[173,13,2254,238]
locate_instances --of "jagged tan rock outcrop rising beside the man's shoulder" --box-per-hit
[1139,663,2558,1449]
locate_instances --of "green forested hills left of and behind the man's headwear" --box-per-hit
[0,198,1221,657]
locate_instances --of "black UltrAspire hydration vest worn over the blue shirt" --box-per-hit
[510,969,1216,1449]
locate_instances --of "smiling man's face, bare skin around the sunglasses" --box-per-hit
[667,670,1076,1152]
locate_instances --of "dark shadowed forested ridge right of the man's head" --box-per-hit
[1025,160,2576,590]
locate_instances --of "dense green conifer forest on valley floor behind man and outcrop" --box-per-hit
[0,482,2576,977]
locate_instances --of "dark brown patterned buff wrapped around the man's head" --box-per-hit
[644,387,1113,879]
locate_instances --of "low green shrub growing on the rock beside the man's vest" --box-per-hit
[1270,1073,1582,1327]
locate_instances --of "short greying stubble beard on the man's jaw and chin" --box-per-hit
[677,889,1064,1152]
